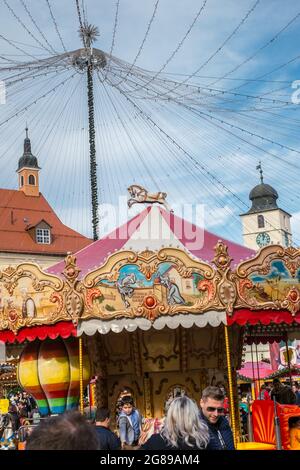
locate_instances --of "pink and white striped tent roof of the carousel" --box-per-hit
[47,205,255,277]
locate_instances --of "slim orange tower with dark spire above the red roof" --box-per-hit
[17,127,40,197]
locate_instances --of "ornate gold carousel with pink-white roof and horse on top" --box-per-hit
[0,193,300,443]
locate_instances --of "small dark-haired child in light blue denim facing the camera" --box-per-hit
[118,395,142,449]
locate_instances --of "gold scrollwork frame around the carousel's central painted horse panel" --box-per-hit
[81,248,222,322]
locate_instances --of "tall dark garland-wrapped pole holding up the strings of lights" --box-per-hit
[86,58,99,240]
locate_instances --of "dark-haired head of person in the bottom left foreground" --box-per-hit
[26,411,100,450]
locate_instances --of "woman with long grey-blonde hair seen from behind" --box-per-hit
[142,396,209,450]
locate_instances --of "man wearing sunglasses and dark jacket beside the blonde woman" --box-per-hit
[200,386,234,450]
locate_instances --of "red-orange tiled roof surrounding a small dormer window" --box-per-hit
[0,189,92,255]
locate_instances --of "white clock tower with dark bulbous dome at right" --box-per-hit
[240,162,292,250]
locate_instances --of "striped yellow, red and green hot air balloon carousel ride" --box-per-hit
[17,338,90,416]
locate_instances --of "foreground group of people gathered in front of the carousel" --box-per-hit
[26,386,234,450]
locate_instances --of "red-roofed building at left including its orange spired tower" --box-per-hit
[0,128,92,269]
